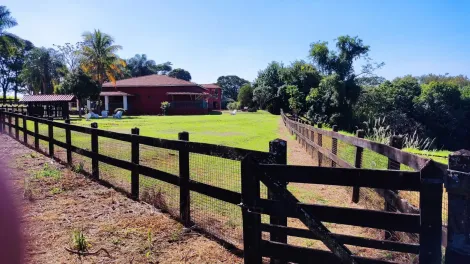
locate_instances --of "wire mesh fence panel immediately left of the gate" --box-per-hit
[189,153,244,245]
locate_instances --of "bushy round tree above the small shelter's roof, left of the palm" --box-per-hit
[20,47,67,94]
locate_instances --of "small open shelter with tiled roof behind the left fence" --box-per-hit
[20,94,75,119]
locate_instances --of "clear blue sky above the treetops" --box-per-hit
[1,0,470,83]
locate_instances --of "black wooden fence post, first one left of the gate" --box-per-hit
[178,131,191,227]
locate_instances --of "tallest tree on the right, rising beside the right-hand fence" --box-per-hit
[309,36,383,128]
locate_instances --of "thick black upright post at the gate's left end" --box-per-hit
[241,155,262,264]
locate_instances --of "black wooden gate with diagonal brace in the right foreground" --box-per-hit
[241,156,442,264]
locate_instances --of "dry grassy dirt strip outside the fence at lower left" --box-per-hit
[0,135,242,263]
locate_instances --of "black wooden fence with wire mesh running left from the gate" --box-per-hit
[0,110,278,248]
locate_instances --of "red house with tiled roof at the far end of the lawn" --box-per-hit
[95,74,222,115]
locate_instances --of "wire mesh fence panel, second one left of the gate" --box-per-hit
[139,145,180,218]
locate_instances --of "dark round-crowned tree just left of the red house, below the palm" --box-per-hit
[57,69,101,117]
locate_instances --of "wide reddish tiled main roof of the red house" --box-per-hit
[103,74,202,88]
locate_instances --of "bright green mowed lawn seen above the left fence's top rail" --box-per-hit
[67,111,280,151]
